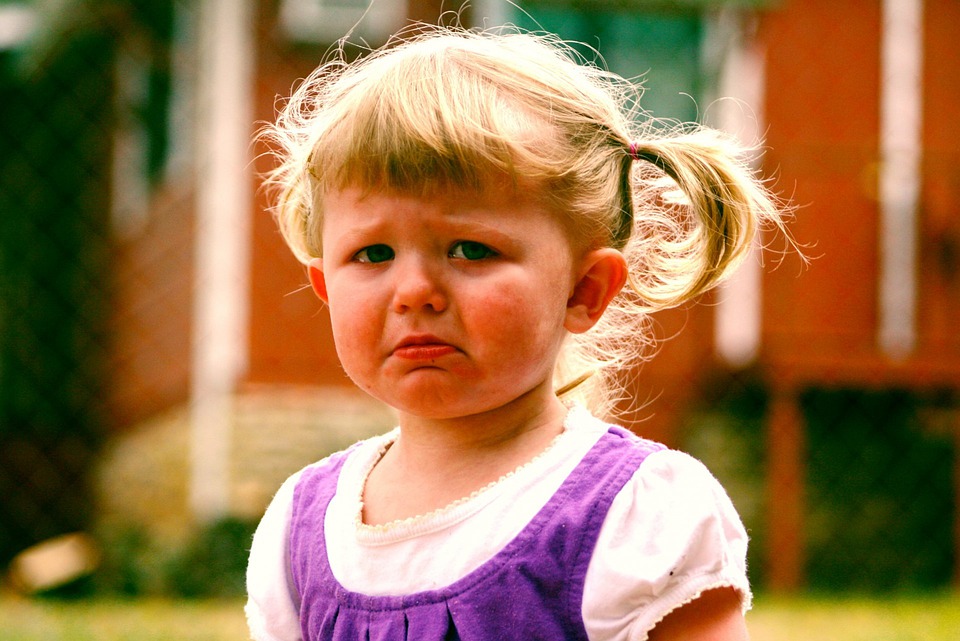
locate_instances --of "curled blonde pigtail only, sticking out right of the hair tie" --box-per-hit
[626,129,782,310]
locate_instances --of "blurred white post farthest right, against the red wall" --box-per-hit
[877,0,923,358]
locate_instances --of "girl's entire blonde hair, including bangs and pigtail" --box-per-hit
[261,27,782,420]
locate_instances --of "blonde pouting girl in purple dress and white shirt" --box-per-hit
[246,29,780,641]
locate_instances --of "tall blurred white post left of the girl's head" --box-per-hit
[190,0,255,520]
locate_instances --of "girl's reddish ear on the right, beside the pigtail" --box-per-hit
[563,247,627,334]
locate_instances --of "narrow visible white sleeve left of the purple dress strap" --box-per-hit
[244,473,301,641]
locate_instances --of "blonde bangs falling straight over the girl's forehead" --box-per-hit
[309,35,558,193]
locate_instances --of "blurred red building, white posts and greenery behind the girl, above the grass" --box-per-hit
[0,0,960,608]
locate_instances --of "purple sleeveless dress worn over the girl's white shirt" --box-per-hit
[290,426,663,641]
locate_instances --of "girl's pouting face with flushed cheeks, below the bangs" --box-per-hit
[310,180,580,419]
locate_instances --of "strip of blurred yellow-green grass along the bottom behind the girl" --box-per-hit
[0,594,960,641]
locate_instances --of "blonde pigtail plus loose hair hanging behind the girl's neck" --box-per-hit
[555,128,789,415]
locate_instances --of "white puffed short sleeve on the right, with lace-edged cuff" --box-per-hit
[583,450,752,641]
